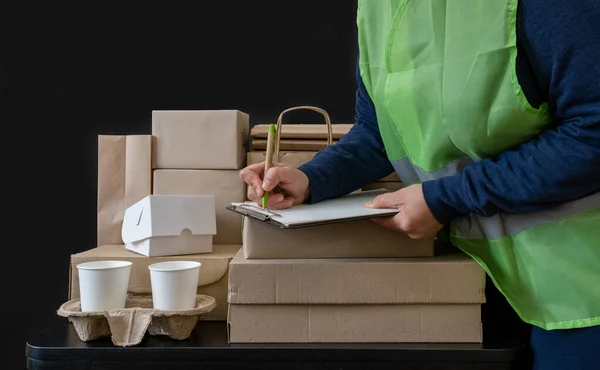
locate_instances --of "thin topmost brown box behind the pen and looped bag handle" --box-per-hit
[250,123,354,140]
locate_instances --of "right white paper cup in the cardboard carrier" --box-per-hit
[148,261,201,311]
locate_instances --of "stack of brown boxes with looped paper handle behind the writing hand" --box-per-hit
[247,106,402,190]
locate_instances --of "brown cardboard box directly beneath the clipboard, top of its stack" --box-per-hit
[243,217,433,259]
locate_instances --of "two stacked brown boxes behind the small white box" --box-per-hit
[152,110,249,244]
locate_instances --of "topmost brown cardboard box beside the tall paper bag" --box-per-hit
[152,110,249,170]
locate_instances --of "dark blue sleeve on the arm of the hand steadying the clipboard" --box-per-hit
[423,0,600,224]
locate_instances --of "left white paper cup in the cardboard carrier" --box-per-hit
[77,261,131,312]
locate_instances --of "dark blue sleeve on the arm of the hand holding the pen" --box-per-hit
[299,62,394,203]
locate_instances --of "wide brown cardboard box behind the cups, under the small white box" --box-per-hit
[68,245,241,321]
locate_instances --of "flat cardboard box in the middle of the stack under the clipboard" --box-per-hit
[228,253,485,304]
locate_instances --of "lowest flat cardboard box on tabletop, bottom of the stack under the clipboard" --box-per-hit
[228,304,483,343]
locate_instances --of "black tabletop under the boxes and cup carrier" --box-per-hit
[26,320,526,370]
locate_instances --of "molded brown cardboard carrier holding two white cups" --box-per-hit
[57,295,216,347]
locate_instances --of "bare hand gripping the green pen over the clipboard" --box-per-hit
[240,162,309,209]
